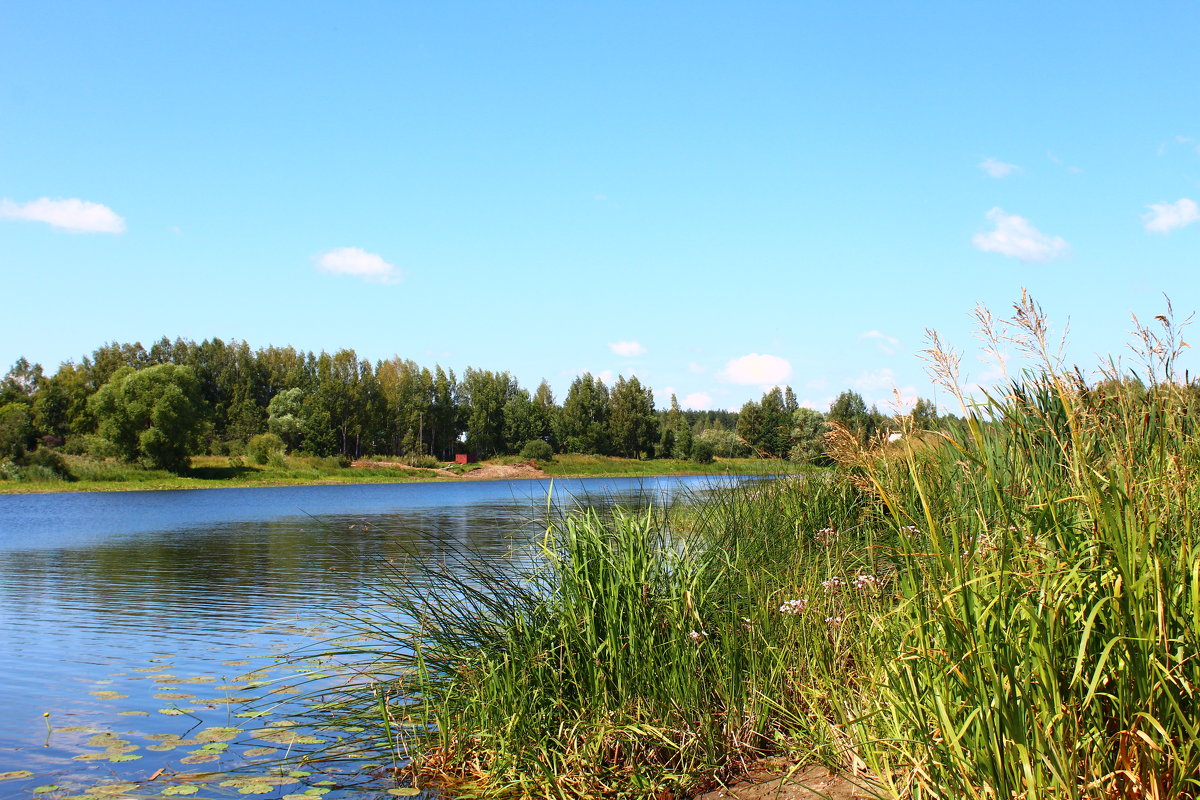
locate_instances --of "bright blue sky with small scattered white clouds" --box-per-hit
[0,1,1200,408]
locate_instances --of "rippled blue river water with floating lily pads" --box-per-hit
[0,477,728,800]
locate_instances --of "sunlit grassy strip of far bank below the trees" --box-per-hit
[0,455,805,494]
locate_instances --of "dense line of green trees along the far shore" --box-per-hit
[0,338,937,470]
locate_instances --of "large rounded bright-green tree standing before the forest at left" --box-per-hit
[89,363,208,471]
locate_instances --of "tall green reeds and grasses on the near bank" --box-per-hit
[317,299,1200,800]
